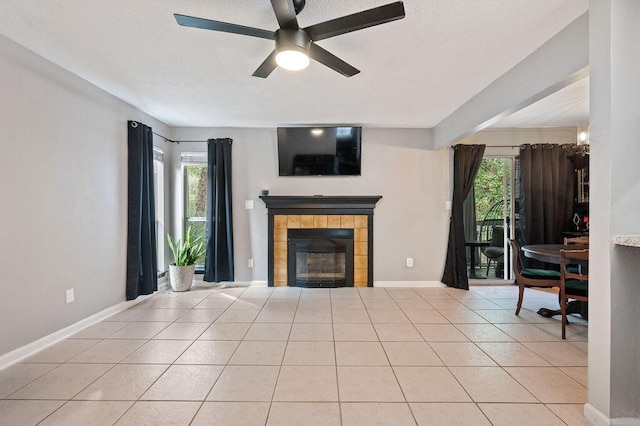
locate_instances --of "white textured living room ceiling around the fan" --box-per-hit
[0,0,588,127]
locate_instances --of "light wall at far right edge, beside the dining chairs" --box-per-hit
[586,0,640,424]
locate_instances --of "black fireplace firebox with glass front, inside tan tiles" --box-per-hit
[287,229,353,287]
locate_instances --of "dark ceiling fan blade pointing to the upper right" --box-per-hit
[304,1,404,41]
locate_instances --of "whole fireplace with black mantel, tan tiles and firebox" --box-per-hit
[260,195,382,287]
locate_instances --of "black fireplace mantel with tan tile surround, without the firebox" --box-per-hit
[260,195,382,287]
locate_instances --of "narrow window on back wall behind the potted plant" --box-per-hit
[181,152,207,265]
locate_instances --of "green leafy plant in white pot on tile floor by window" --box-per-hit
[167,227,206,291]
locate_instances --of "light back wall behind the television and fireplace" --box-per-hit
[173,128,450,285]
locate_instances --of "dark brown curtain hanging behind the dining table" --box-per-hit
[518,144,576,258]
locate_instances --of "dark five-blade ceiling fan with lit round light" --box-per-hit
[174,0,405,78]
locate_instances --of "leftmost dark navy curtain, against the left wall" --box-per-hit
[127,121,158,300]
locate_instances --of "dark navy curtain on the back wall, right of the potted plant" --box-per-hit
[204,139,233,283]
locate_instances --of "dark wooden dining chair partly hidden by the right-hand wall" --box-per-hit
[560,249,589,339]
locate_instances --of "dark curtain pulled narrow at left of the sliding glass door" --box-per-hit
[441,145,485,290]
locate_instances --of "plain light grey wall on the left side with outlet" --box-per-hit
[0,36,168,355]
